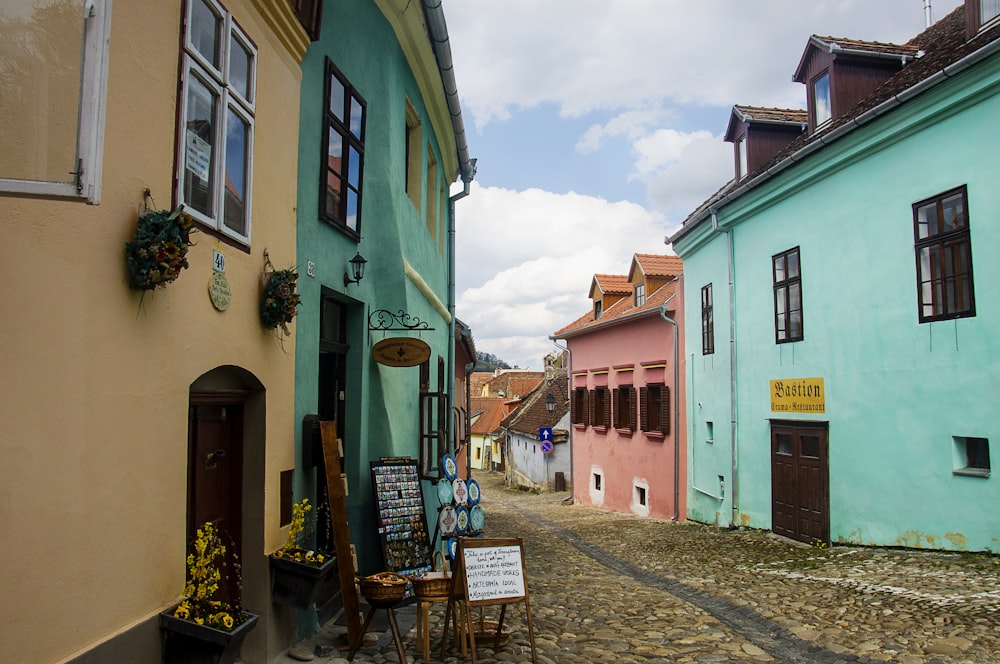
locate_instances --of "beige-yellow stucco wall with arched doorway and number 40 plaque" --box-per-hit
[0,0,299,662]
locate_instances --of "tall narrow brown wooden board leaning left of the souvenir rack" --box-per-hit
[319,421,364,643]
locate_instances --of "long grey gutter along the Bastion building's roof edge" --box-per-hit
[669,34,1000,244]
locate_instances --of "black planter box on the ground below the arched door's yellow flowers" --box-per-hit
[160,610,257,664]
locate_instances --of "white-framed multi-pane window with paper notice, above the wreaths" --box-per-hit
[176,0,257,244]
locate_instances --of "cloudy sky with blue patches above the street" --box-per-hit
[444,0,960,370]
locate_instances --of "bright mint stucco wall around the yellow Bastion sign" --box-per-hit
[678,58,1000,550]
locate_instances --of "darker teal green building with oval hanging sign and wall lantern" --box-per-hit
[292,0,474,574]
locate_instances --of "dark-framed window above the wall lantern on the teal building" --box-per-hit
[319,58,367,238]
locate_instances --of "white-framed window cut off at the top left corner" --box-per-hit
[0,0,111,205]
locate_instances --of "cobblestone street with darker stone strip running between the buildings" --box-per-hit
[280,473,1000,664]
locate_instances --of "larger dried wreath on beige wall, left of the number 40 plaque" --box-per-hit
[125,200,193,291]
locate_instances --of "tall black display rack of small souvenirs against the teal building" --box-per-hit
[371,458,433,574]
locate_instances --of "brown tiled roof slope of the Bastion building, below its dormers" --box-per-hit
[670,5,1000,242]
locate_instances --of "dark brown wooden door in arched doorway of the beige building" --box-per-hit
[187,394,243,602]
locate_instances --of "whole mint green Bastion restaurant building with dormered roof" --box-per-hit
[669,5,1000,551]
